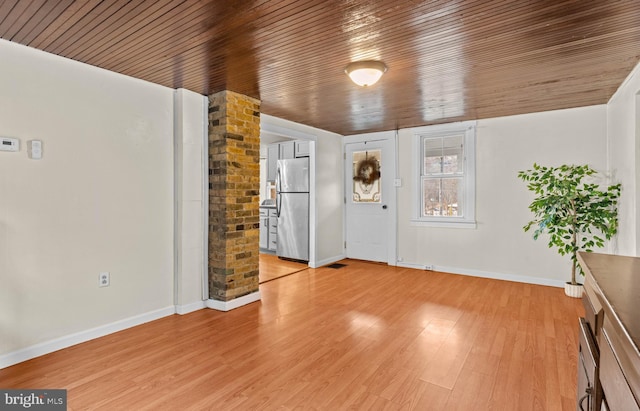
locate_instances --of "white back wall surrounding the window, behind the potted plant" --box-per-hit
[398,105,606,286]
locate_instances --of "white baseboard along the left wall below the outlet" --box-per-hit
[0,306,175,369]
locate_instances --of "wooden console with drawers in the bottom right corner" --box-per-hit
[577,252,640,411]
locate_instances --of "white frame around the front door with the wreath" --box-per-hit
[342,131,398,265]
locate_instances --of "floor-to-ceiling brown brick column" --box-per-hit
[209,90,260,301]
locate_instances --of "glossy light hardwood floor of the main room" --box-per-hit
[0,260,583,411]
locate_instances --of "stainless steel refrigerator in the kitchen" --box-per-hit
[276,158,309,261]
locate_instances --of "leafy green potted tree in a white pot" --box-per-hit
[518,164,621,297]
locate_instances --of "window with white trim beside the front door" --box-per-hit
[412,122,476,228]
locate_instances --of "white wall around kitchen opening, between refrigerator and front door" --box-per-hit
[260,114,344,267]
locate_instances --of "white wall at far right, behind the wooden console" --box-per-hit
[607,59,640,255]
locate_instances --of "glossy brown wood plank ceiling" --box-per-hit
[0,0,640,135]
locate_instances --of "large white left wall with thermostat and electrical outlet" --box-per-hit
[0,40,174,360]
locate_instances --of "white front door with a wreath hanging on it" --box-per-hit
[345,139,396,265]
